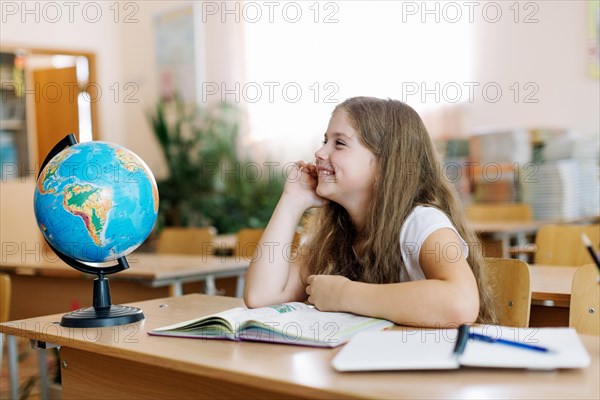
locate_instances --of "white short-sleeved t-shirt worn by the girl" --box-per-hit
[400,206,469,282]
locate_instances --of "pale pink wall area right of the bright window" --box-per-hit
[465,1,600,135]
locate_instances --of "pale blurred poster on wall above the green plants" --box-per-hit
[155,6,196,102]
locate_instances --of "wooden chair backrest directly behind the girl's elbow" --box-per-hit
[485,258,531,328]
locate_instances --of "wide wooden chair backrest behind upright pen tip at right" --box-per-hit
[535,224,600,266]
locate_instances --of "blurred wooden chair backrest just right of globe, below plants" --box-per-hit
[156,227,217,255]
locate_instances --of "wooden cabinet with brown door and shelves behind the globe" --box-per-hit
[0,46,99,182]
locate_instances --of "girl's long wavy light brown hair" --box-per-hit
[303,97,496,323]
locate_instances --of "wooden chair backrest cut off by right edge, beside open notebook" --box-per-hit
[569,264,600,335]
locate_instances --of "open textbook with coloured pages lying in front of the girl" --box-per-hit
[148,302,394,347]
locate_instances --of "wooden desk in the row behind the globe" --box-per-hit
[0,253,249,319]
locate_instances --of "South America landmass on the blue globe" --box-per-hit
[63,184,112,246]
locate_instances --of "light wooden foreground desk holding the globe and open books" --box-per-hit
[0,294,600,400]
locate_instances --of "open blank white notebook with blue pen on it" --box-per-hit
[332,325,590,371]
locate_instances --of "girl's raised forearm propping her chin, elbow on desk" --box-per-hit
[244,195,304,307]
